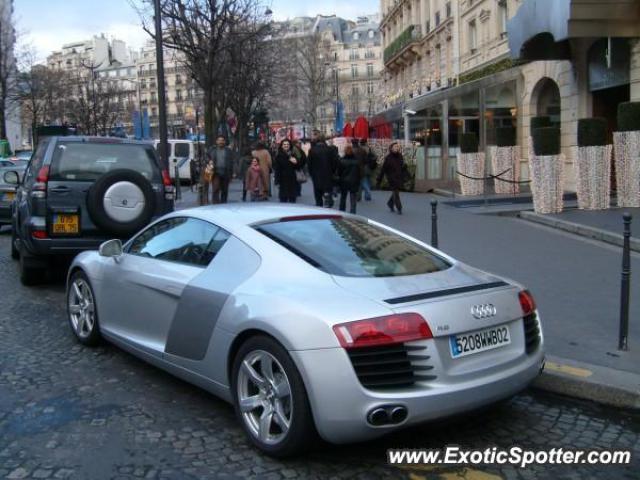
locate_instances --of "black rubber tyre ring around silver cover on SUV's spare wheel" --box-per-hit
[87,169,156,238]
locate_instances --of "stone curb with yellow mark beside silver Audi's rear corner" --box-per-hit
[532,355,640,411]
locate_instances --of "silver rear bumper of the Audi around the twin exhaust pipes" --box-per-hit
[291,348,544,443]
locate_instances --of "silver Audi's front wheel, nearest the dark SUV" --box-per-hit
[66,270,102,347]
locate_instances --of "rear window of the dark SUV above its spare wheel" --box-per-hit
[50,142,160,182]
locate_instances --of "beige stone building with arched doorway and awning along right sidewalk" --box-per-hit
[374,0,640,190]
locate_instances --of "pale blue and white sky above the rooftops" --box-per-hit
[14,0,380,60]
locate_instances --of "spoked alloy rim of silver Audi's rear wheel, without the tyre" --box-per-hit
[237,350,293,445]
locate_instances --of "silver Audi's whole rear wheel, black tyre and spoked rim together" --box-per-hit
[231,336,318,458]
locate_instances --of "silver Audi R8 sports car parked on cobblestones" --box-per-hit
[67,204,544,456]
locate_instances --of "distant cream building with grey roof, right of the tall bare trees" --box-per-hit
[268,15,382,137]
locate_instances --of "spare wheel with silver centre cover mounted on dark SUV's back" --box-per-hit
[87,169,156,236]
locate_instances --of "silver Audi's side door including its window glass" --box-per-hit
[99,217,219,357]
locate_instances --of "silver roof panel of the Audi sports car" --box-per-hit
[172,203,343,230]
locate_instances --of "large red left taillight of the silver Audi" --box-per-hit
[333,313,433,349]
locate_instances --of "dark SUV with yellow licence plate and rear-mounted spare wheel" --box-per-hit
[5,136,175,285]
